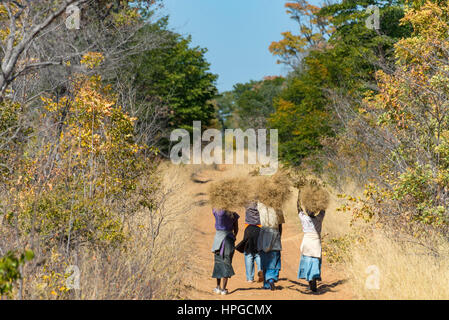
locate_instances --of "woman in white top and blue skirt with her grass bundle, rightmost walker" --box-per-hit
[297,185,329,292]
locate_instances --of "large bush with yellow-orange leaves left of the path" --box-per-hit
[2,53,159,250]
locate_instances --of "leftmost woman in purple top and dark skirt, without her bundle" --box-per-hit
[212,209,239,295]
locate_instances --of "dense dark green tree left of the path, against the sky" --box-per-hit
[133,19,217,130]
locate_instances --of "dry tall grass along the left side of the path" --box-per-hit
[0,165,192,300]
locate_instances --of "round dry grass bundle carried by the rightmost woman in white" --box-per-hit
[298,183,330,214]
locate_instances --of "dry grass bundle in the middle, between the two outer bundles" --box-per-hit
[255,172,292,210]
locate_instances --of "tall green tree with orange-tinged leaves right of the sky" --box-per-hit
[270,0,410,165]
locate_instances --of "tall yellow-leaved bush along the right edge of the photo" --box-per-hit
[336,1,449,236]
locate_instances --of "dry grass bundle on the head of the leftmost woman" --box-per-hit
[209,177,253,210]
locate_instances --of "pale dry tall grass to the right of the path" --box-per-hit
[323,182,449,300]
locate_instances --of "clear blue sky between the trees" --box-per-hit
[163,0,304,92]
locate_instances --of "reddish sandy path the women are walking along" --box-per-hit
[180,165,353,300]
